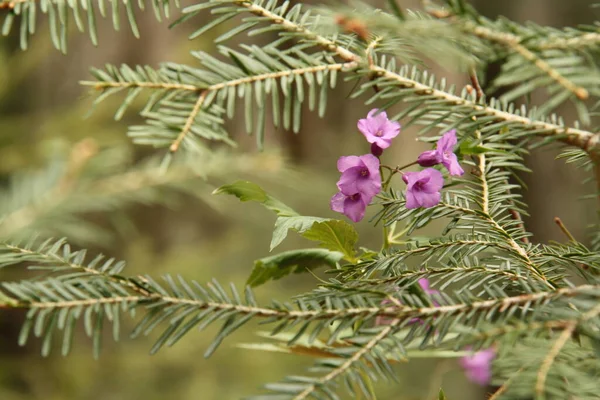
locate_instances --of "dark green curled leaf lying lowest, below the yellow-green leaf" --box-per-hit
[246,249,344,287]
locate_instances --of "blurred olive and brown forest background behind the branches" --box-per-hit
[0,0,597,400]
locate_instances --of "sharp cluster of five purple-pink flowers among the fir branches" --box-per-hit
[330,109,464,222]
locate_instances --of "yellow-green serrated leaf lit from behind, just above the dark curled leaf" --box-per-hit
[302,219,358,262]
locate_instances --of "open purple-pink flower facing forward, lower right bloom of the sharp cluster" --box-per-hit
[402,168,444,208]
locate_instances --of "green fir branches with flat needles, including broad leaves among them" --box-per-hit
[0,0,600,400]
